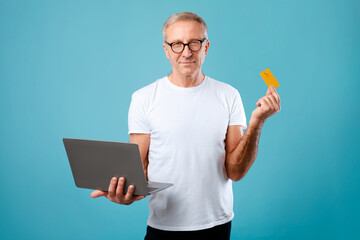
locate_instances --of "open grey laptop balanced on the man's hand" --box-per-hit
[63,138,173,196]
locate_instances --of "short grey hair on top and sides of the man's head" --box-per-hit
[162,12,207,40]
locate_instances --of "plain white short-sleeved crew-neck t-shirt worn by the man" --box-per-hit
[129,76,246,231]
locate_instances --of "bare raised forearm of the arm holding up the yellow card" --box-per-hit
[226,118,264,181]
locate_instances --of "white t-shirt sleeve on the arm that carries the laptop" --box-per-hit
[128,92,150,134]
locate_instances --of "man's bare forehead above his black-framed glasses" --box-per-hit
[166,21,203,42]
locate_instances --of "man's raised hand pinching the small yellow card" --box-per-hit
[251,86,280,123]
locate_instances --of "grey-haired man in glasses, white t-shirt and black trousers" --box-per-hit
[91,12,280,239]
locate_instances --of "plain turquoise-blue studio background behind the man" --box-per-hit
[0,0,360,239]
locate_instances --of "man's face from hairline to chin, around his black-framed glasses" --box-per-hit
[163,21,209,76]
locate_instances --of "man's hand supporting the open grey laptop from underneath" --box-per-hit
[91,177,145,205]
